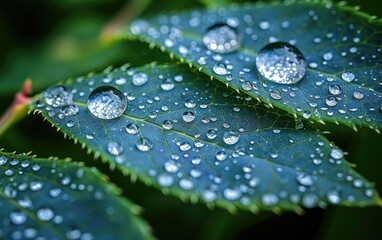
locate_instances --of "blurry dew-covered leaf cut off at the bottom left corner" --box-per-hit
[0,152,151,239]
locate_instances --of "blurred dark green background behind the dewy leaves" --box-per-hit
[0,0,382,240]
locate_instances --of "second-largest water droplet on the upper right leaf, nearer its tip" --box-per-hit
[203,23,240,54]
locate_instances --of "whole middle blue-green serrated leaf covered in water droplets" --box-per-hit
[32,65,379,211]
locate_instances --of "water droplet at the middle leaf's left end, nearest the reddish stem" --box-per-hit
[44,86,73,107]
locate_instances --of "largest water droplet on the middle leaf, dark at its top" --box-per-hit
[87,86,127,119]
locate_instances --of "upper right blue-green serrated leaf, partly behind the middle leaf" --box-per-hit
[121,1,382,132]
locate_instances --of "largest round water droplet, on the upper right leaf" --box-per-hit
[256,42,306,84]
